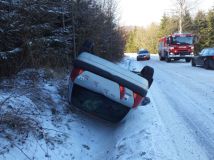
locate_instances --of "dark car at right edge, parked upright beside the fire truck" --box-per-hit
[192,48,214,69]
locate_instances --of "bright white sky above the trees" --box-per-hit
[118,0,214,27]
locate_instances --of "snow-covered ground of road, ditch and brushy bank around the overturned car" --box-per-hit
[0,56,214,160]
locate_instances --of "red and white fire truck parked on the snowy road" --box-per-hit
[158,33,195,62]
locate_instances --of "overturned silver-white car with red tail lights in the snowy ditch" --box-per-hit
[68,52,154,122]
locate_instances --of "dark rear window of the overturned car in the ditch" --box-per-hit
[72,85,130,122]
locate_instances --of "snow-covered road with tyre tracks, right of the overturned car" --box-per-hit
[118,56,214,160]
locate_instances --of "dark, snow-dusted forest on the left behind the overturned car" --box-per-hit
[0,0,125,75]
